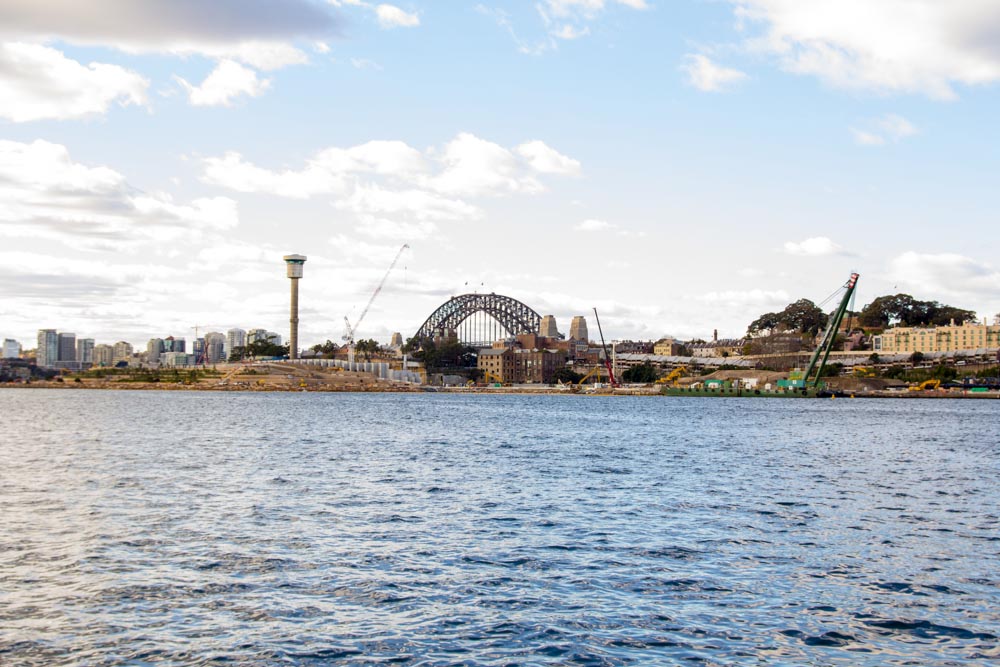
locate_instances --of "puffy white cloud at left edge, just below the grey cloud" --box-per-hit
[0,42,149,123]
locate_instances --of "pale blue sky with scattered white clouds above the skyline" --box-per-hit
[0,0,1000,348]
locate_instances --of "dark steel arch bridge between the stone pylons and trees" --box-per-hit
[415,294,542,347]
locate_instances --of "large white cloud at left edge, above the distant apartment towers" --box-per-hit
[0,141,239,248]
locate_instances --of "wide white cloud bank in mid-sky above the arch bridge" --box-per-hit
[202,133,580,245]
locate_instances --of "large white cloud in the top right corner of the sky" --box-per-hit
[730,0,1000,99]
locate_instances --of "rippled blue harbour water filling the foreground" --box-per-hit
[0,389,1000,665]
